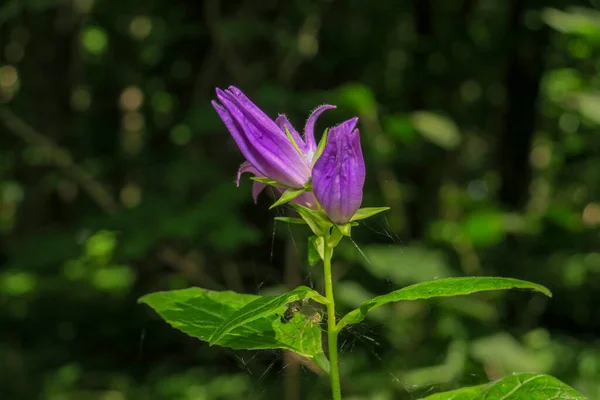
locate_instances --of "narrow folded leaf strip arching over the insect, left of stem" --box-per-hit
[209,286,328,346]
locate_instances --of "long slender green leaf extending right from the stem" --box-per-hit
[338,277,552,329]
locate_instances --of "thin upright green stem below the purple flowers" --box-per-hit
[323,237,342,400]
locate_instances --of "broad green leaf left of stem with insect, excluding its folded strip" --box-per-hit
[138,288,329,372]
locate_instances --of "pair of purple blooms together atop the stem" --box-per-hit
[212,86,365,224]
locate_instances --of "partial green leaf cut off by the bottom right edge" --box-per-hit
[422,373,587,400]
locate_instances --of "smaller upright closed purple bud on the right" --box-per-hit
[312,118,365,224]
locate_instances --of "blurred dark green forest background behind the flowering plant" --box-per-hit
[0,0,600,400]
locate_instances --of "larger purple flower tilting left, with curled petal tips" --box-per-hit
[212,86,335,205]
